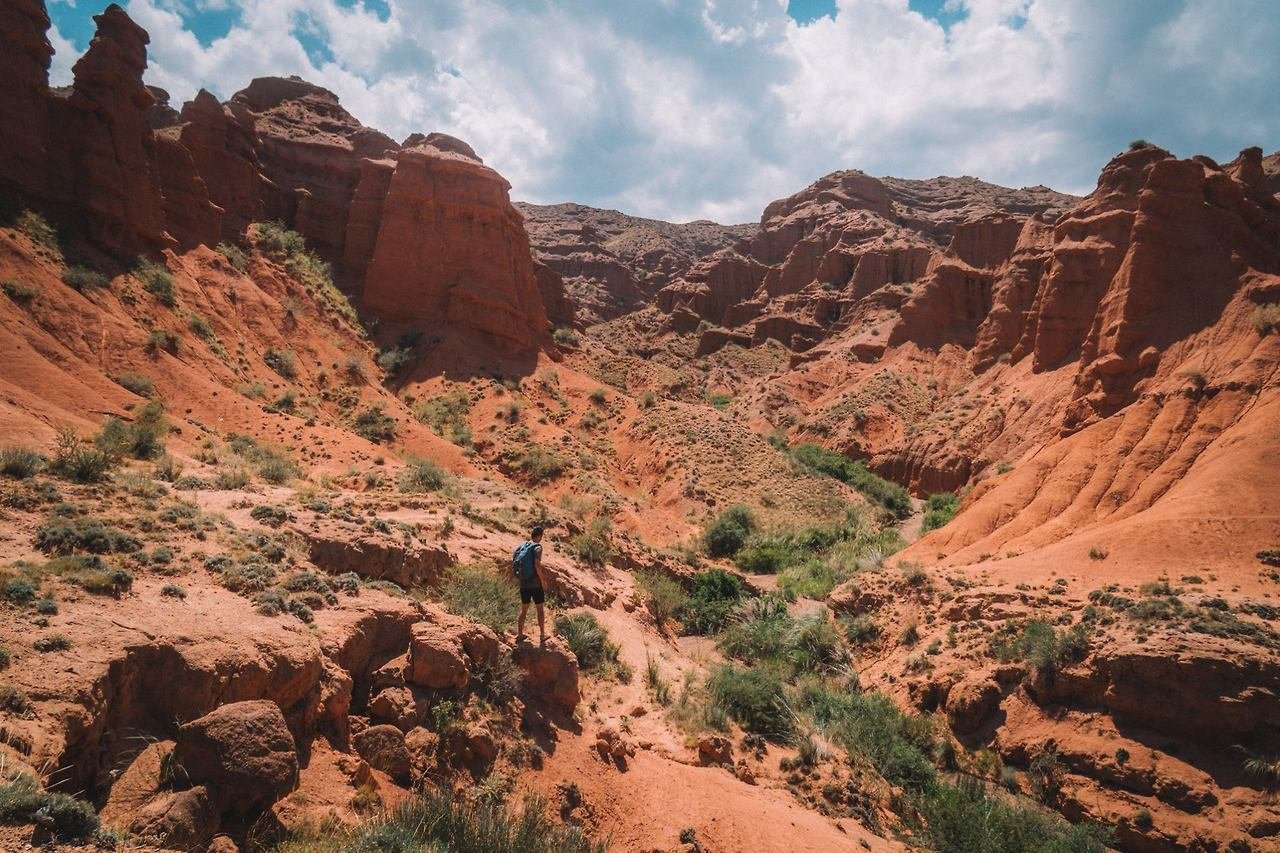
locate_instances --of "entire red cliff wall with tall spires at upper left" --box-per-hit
[0,0,573,352]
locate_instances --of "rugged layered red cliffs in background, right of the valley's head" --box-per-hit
[657,172,1074,353]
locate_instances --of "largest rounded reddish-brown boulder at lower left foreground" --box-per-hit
[174,699,298,815]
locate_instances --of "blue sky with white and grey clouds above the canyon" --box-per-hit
[49,0,1280,222]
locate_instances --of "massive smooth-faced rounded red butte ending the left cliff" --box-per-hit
[365,146,548,350]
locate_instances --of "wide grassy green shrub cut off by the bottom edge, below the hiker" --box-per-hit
[276,786,605,853]
